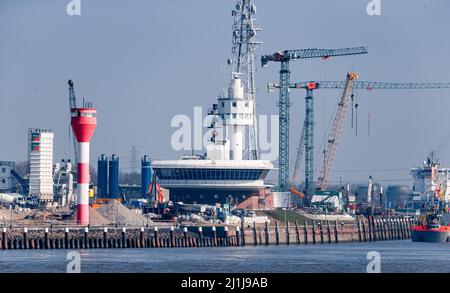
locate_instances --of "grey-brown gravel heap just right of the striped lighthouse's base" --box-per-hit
[97,201,147,225]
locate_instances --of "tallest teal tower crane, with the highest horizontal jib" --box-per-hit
[261,47,367,191]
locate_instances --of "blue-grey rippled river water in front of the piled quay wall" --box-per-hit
[0,240,450,273]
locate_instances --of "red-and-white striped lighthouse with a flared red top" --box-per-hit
[70,108,97,225]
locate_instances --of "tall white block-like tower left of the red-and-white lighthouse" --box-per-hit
[28,128,54,202]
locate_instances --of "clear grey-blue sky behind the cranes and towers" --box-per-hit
[0,0,450,184]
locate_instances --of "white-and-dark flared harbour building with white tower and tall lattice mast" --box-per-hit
[152,0,274,204]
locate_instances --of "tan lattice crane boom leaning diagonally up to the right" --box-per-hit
[317,72,358,190]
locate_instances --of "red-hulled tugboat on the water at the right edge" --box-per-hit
[412,209,450,243]
